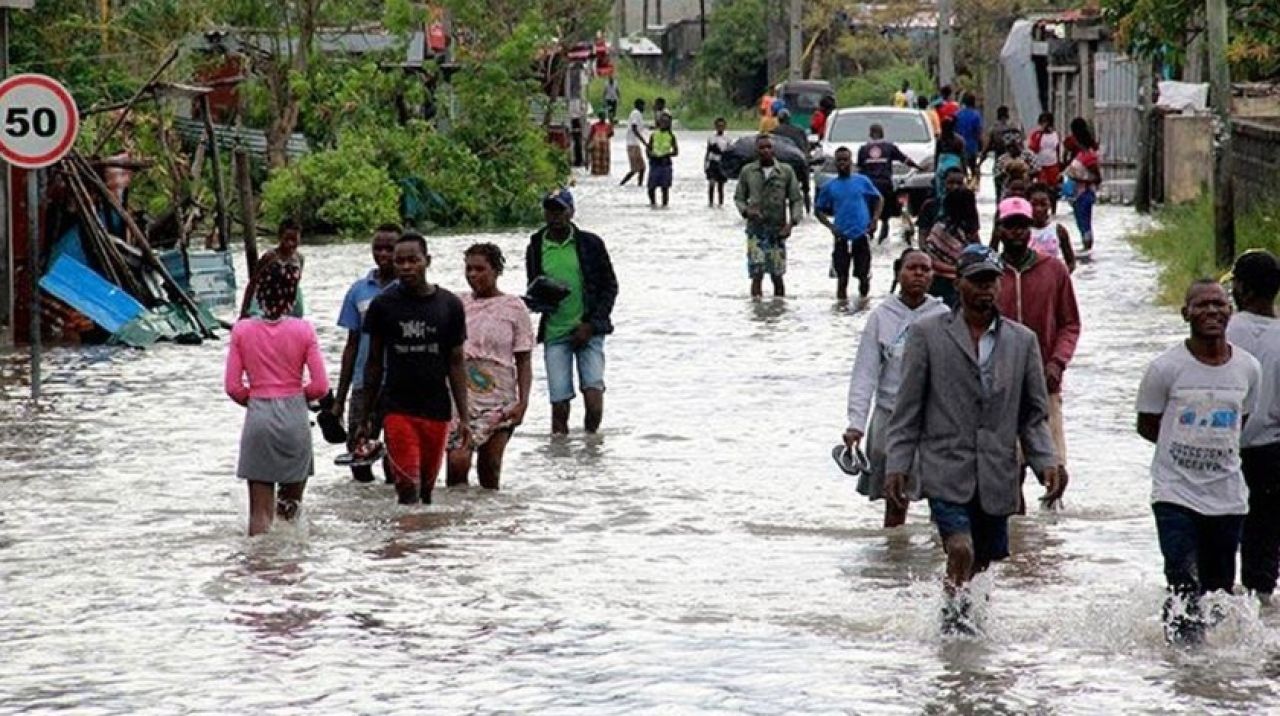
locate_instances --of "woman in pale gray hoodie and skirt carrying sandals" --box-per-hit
[844,248,947,528]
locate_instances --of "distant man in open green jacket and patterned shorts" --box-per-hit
[733,134,804,298]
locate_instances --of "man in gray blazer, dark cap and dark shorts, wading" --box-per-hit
[884,245,1060,630]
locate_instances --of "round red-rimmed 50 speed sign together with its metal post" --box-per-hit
[0,74,79,400]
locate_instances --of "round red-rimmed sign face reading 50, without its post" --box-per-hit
[0,74,79,169]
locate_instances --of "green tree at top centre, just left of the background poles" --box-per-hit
[698,0,768,106]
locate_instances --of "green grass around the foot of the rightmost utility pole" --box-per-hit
[1132,192,1280,306]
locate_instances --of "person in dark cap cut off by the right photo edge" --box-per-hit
[1226,251,1280,602]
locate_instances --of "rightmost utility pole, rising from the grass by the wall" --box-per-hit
[1204,0,1235,266]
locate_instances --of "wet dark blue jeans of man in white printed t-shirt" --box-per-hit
[1151,502,1244,634]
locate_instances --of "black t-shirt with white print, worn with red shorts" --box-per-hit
[364,284,467,420]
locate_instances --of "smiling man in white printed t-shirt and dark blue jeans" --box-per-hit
[1137,279,1262,643]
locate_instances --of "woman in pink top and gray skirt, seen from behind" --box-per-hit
[224,261,329,537]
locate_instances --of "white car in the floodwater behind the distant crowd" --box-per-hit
[814,106,933,214]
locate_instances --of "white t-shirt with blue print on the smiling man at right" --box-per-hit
[1138,343,1262,515]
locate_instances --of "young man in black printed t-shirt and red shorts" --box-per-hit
[361,232,471,505]
